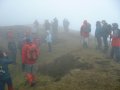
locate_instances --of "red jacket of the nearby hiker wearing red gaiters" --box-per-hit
[22,43,40,64]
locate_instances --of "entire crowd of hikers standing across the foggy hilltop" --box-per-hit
[0,18,120,90]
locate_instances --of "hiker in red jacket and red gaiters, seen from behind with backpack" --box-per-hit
[22,38,39,86]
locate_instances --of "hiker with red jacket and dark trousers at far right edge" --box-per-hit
[111,23,120,62]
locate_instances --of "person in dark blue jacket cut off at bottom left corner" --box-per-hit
[0,50,13,90]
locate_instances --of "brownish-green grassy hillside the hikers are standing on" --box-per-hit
[4,32,120,90]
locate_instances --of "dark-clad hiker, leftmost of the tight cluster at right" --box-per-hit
[95,21,102,50]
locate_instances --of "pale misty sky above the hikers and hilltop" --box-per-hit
[0,0,120,30]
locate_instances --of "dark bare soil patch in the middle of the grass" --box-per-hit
[39,54,93,81]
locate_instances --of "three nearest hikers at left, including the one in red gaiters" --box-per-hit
[0,30,40,90]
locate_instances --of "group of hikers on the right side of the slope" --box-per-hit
[80,20,120,62]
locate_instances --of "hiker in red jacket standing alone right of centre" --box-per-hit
[80,20,91,48]
